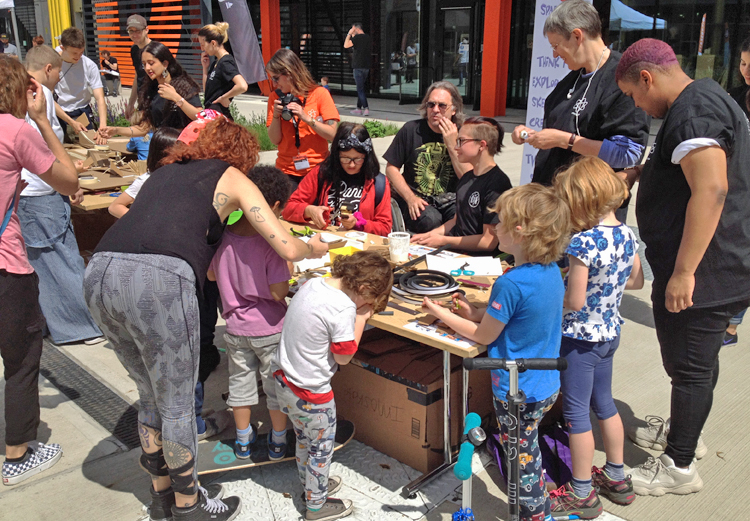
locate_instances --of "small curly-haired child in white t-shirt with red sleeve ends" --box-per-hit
[274,251,393,521]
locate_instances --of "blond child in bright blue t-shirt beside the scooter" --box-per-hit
[423,184,570,521]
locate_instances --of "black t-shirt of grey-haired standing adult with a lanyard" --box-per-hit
[531,51,651,185]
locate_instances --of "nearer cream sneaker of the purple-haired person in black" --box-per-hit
[630,454,703,496]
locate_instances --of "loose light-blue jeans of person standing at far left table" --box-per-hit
[18,193,102,344]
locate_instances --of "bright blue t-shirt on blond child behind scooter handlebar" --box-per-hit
[487,263,565,403]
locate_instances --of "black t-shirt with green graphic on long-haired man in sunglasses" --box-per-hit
[383,119,458,197]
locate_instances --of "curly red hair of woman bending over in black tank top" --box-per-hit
[161,118,260,174]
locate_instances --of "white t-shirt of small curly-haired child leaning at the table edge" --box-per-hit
[275,279,357,394]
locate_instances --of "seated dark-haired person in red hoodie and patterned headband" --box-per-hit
[283,122,393,235]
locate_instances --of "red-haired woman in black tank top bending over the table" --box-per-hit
[84,118,327,520]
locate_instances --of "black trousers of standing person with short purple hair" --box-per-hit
[651,288,750,467]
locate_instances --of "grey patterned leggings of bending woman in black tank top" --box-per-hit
[83,252,200,479]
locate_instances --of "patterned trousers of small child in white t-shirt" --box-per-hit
[275,376,336,509]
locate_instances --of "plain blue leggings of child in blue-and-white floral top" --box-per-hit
[560,336,620,434]
